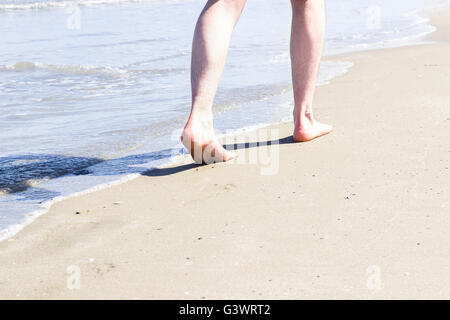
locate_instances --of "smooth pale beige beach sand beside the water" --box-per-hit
[0,9,450,299]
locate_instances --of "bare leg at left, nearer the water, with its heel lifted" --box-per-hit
[181,0,246,163]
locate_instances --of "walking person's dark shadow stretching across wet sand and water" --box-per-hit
[0,136,294,201]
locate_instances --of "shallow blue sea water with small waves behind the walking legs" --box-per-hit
[0,0,448,239]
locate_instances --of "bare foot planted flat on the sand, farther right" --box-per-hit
[293,113,333,142]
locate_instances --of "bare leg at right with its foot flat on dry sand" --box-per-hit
[291,0,332,141]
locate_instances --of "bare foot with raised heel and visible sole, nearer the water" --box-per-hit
[181,115,237,164]
